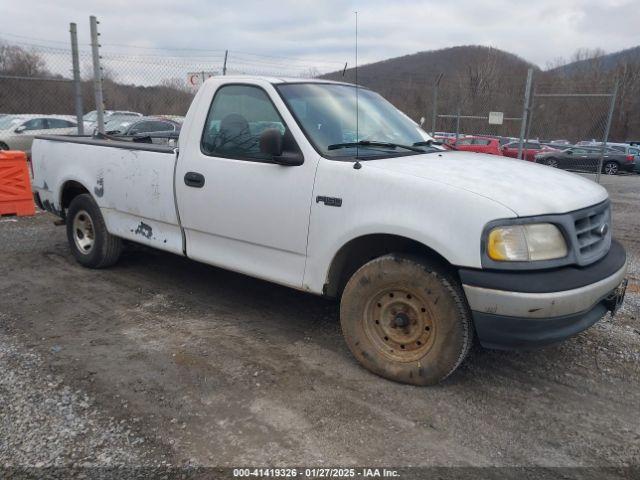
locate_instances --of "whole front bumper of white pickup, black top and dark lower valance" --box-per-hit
[460,241,626,349]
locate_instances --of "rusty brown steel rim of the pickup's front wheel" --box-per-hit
[363,287,436,362]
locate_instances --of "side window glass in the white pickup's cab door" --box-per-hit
[201,85,286,161]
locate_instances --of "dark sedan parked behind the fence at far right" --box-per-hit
[536,147,635,175]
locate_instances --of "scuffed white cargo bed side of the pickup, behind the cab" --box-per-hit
[32,136,184,254]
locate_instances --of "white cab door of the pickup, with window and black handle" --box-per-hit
[175,84,319,288]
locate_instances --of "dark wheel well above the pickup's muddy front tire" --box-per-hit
[323,234,457,297]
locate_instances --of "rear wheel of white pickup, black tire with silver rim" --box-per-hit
[66,193,122,268]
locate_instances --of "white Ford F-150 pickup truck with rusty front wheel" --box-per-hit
[33,77,626,385]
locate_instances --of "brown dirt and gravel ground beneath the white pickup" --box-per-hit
[0,175,640,476]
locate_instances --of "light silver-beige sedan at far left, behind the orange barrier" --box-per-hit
[0,115,78,155]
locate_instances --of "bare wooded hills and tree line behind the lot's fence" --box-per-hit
[0,44,640,141]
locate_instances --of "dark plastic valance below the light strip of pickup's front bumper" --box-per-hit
[473,302,609,350]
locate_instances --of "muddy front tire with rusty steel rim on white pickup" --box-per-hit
[340,254,473,385]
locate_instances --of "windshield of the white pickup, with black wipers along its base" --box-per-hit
[277,83,440,158]
